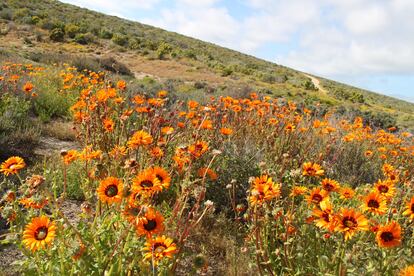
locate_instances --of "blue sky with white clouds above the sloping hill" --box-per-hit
[63,0,414,102]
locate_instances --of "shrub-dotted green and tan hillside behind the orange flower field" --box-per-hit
[0,0,414,129]
